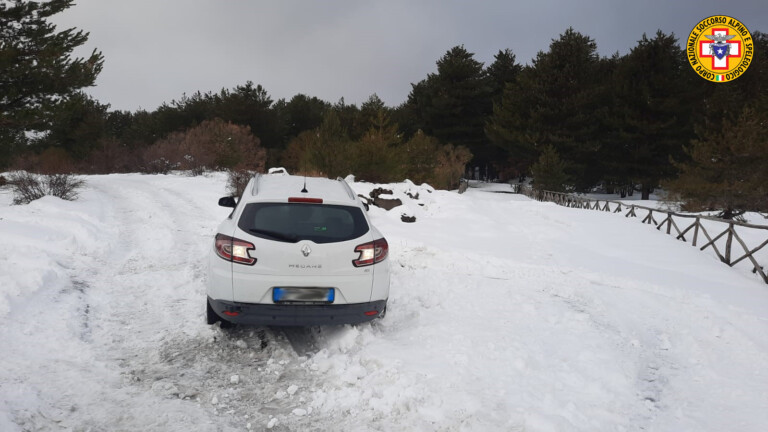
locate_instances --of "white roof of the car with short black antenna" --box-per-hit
[248,175,356,205]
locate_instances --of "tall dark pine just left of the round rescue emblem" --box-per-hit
[610,31,701,199]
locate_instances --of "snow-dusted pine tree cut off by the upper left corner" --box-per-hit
[0,0,103,166]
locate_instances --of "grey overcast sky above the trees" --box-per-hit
[54,0,768,110]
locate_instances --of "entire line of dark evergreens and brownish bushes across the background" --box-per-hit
[0,0,768,210]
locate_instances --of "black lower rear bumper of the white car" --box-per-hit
[208,297,387,326]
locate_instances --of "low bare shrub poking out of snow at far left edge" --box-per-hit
[8,171,85,205]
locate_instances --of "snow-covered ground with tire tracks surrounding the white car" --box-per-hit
[0,175,768,432]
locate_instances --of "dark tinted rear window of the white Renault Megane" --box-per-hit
[237,203,369,243]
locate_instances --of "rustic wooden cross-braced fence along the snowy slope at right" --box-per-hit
[518,187,768,283]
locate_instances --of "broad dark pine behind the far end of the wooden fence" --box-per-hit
[485,28,609,189]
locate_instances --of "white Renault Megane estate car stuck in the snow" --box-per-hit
[207,174,389,326]
